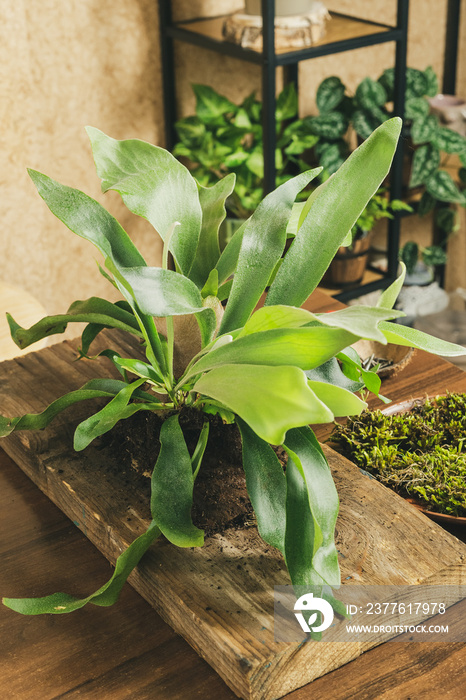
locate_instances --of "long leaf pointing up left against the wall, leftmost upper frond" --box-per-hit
[28,170,146,268]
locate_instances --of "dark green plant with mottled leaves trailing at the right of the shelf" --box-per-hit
[305,67,466,234]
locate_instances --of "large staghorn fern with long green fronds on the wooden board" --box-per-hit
[0,119,464,614]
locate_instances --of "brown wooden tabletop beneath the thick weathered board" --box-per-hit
[0,292,466,700]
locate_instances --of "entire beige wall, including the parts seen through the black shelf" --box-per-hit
[0,0,466,322]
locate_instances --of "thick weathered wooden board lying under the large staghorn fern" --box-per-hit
[0,336,466,699]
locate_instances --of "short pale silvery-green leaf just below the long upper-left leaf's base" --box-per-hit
[124,267,203,317]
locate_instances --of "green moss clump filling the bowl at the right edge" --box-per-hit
[330,394,466,517]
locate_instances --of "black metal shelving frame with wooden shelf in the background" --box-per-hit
[159,0,410,301]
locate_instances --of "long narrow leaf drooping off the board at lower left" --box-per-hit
[3,522,160,615]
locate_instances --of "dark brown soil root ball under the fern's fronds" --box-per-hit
[100,409,255,537]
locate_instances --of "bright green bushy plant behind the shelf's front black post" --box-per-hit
[173,83,317,219]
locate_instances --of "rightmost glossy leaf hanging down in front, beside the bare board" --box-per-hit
[285,426,340,587]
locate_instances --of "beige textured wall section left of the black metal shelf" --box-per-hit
[0,0,162,320]
